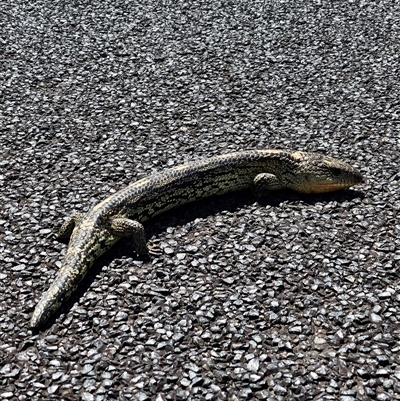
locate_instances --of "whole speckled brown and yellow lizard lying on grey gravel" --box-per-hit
[30,150,363,327]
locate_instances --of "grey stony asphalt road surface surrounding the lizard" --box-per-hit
[0,0,400,401]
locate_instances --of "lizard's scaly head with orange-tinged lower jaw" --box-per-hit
[288,152,363,193]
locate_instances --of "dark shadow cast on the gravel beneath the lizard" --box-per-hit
[36,189,365,330]
